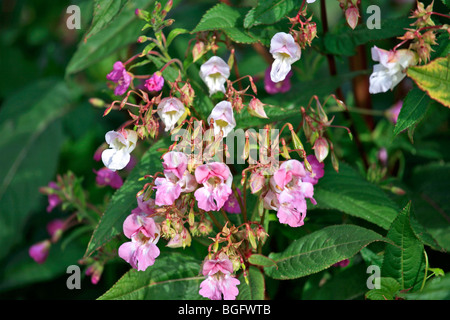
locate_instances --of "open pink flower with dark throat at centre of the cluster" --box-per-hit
[194,162,233,211]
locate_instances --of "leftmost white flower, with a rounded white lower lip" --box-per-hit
[102,130,137,171]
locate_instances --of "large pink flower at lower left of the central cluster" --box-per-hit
[119,213,161,271]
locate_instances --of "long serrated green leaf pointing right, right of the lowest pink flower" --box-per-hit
[264,225,384,280]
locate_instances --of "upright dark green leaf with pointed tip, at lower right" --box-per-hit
[381,203,425,291]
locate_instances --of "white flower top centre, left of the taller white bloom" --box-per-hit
[200,56,230,95]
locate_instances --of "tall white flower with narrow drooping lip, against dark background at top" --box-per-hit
[270,32,302,82]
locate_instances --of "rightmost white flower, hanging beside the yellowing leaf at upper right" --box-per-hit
[369,46,417,94]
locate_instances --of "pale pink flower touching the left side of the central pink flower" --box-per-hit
[155,151,197,206]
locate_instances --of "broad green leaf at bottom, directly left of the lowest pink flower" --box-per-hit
[98,253,205,300]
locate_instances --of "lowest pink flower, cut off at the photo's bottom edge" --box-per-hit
[199,255,240,300]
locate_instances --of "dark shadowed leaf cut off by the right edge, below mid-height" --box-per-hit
[410,163,450,252]
